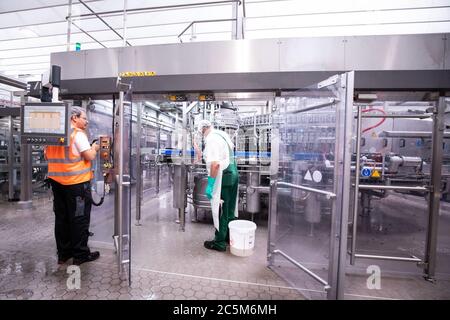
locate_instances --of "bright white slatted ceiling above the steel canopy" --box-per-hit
[0,0,450,93]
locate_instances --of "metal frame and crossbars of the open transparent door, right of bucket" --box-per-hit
[267,71,354,299]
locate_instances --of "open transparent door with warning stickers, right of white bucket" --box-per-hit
[269,76,352,299]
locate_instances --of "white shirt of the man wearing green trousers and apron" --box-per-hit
[203,129,234,173]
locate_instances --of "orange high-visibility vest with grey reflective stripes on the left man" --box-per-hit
[46,128,93,185]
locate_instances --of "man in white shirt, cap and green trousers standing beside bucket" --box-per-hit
[198,120,239,251]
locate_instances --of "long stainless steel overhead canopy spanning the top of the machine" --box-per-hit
[51,34,450,90]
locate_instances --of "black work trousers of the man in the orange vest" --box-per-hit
[50,179,92,259]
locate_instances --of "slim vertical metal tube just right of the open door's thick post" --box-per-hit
[350,106,362,265]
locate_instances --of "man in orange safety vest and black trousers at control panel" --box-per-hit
[45,107,100,265]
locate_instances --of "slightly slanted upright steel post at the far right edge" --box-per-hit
[425,97,450,280]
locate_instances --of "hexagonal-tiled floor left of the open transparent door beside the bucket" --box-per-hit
[0,194,303,300]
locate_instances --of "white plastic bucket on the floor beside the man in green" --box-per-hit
[228,220,256,257]
